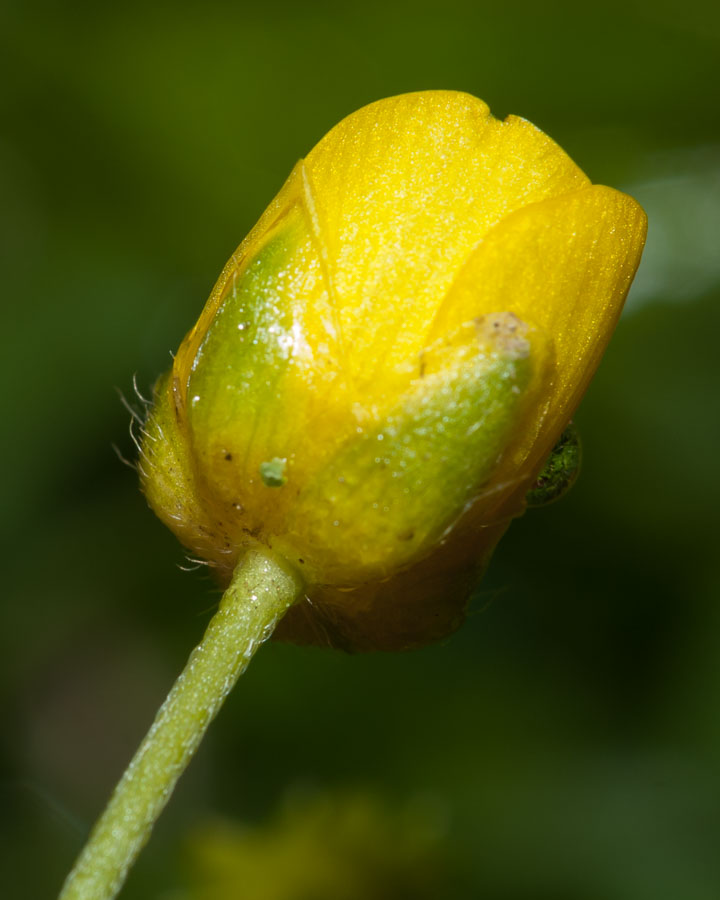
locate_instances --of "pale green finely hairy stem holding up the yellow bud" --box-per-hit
[60,549,303,900]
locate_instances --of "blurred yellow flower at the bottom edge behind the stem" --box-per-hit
[178,791,448,900]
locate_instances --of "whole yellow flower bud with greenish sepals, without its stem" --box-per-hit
[141,91,646,649]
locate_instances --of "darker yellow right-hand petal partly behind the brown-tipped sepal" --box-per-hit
[428,186,647,492]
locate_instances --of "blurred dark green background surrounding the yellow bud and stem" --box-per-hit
[0,0,720,900]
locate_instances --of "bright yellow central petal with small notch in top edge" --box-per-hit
[303,91,589,392]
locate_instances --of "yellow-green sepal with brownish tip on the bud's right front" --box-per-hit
[279,313,544,581]
